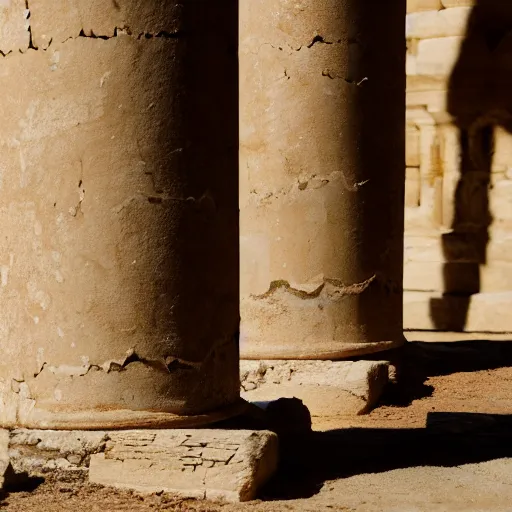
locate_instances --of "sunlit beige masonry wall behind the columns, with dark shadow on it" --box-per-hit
[404,0,512,332]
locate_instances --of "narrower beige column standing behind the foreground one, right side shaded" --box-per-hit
[240,0,405,359]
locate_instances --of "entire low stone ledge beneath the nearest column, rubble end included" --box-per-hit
[0,429,278,502]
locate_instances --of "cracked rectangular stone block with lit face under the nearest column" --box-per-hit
[89,430,278,502]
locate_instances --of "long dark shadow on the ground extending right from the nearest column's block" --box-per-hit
[261,413,512,500]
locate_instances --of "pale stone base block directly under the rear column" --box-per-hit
[240,360,389,416]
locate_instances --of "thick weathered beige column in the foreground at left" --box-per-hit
[0,0,239,429]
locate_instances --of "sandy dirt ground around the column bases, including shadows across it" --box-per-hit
[0,334,512,512]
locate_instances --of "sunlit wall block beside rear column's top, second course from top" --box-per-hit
[405,7,471,39]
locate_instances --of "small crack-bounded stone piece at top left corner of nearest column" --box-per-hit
[0,0,30,55]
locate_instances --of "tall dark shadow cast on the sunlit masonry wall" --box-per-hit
[430,0,512,332]
